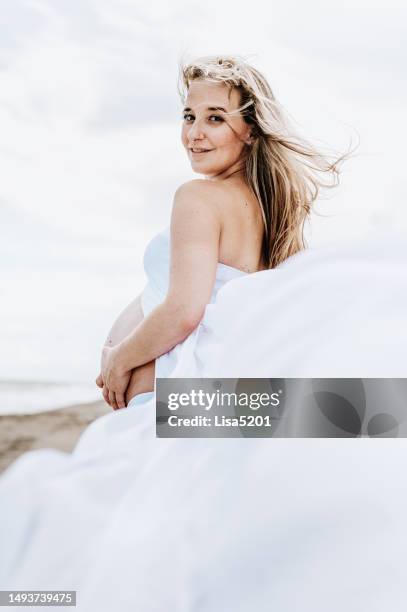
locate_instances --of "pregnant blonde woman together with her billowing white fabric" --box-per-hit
[0,57,407,612]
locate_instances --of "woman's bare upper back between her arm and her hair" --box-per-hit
[215,181,267,274]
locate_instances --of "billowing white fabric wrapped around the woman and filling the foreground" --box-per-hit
[0,222,407,612]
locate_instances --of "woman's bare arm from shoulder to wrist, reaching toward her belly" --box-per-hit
[106,179,224,376]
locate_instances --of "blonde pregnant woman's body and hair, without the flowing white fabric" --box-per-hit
[96,56,352,409]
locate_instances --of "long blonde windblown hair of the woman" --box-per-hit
[178,55,358,268]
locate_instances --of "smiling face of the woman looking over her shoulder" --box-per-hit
[181,80,250,179]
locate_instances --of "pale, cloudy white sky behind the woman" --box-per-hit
[0,0,407,406]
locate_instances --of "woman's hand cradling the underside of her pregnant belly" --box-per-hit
[96,345,132,410]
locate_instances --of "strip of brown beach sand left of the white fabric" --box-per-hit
[0,400,112,472]
